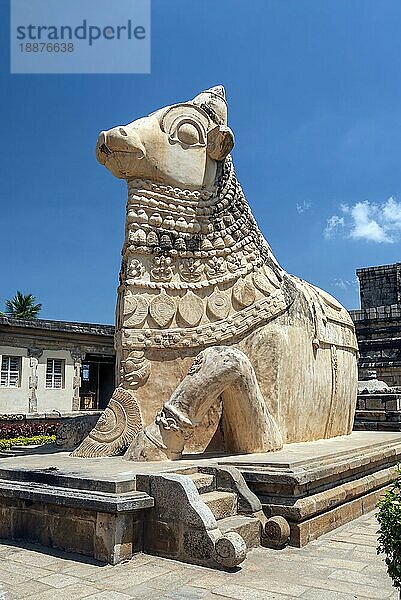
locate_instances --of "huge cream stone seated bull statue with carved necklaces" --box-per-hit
[74,86,357,460]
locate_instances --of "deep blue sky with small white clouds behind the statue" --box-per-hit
[0,0,401,323]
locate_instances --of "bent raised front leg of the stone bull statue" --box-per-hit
[126,346,283,460]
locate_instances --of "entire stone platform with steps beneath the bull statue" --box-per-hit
[0,432,401,566]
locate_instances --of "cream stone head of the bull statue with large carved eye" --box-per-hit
[96,86,234,189]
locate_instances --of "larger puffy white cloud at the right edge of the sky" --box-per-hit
[323,197,401,244]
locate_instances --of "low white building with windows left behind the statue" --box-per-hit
[0,317,115,414]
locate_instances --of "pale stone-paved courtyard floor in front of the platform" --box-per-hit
[0,513,398,600]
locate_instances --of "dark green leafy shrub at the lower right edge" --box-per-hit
[377,467,401,590]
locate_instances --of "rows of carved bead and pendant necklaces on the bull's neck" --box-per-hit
[117,158,293,349]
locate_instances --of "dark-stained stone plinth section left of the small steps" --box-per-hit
[0,460,154,565]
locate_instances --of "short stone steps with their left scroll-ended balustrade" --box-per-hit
[137,468,253,567]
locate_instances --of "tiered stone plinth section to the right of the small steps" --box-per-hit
[216,431,401,547]
